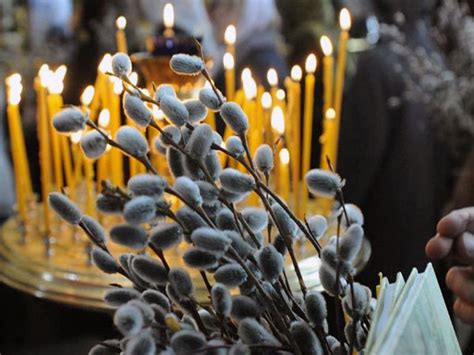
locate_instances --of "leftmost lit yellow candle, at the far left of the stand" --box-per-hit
[6,74,32,223]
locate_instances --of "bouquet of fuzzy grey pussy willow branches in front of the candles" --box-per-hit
[49,48,372,355]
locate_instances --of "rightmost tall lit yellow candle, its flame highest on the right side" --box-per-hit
[328,9,351,169]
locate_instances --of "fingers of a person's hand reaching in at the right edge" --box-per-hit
[426,207,474,323]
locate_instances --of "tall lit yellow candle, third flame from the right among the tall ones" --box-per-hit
[297,54,317,217]
